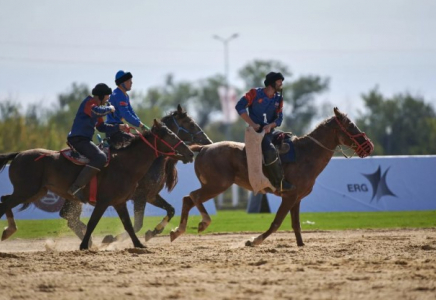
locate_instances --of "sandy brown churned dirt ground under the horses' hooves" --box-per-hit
[0,229,436,300]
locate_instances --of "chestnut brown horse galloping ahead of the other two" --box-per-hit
[170,108,374,246]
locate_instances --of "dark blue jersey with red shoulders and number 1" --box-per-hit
[235,88,283,126]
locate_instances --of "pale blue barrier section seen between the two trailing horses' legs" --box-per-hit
[0,162,216,220]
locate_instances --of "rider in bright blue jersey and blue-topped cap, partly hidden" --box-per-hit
[106,70,149,146]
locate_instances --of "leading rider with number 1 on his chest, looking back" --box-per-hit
[235,72,295,192]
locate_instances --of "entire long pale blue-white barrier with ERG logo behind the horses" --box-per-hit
[0,156,436,219]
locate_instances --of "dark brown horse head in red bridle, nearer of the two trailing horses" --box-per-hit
[148,119,194,163]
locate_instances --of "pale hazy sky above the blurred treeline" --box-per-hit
[0,0,436,121]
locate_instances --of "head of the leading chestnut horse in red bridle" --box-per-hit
[333,107,374,158]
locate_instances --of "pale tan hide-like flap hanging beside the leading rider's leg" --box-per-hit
[245,127,275,195]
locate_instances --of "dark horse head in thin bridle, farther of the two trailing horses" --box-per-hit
[162,104,212,145]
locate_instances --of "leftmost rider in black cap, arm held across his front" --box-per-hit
[67,83,128,202]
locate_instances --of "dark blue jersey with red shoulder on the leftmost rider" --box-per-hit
[68,96,118,140]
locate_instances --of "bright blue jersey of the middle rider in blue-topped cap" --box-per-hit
[107,88,141,127]
